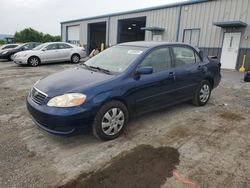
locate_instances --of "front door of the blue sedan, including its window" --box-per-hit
[136,47,175,114]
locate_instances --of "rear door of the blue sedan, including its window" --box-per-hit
[172,45,205,100]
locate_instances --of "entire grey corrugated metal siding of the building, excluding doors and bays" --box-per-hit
[62,0,250,48]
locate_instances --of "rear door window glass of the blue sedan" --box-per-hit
[173,47,196,67]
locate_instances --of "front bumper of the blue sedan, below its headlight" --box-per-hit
[26,94,95,135]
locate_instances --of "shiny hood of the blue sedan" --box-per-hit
[35,67,115,97]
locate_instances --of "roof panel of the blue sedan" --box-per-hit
[119,41,200,52]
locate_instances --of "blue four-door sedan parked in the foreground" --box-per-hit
[27,42,221,140]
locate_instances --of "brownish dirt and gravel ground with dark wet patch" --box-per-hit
[0,62,250,188]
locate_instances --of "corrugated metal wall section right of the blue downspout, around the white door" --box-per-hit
[179,0,250,48]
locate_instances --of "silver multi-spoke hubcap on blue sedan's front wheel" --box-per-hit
[102,108,125,136]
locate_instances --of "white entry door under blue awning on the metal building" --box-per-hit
[221,32,241,69]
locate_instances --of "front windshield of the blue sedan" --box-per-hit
[84,46,145,73]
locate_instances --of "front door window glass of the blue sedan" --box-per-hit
[139,47,171,72]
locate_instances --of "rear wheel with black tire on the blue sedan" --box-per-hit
[192,80,212,106]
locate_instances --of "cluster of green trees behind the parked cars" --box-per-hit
[14,28,61,43]
